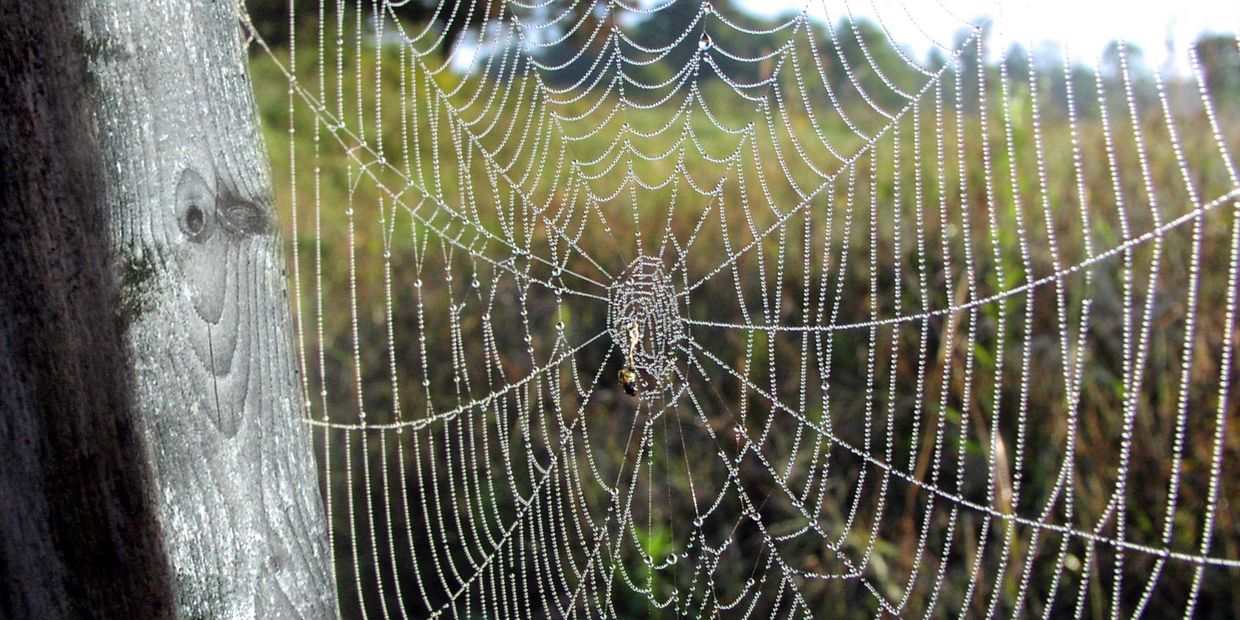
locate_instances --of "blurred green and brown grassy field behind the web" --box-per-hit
[250,13,1240,618]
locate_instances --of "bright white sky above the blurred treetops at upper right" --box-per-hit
[735,0,1240,64]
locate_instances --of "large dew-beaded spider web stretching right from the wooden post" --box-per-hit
[244,0,1240,618]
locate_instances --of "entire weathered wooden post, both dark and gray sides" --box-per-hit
[0,0,336,618]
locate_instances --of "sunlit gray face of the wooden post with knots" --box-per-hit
[0,0,336,618]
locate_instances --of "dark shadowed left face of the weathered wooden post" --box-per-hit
[0,2,174,619]
